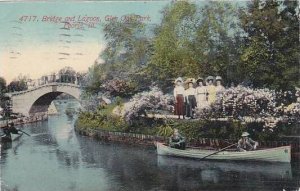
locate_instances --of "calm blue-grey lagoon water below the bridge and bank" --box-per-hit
[0,100,300,191]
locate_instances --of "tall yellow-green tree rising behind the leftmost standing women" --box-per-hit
[148,1,198,89]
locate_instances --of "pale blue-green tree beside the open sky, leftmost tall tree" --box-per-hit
[86,14,151,94]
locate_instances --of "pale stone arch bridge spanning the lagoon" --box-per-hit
[8,83,81,116]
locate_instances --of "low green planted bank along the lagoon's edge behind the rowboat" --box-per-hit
[75,104,298,141]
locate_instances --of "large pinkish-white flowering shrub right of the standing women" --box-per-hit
[196,86,300,128]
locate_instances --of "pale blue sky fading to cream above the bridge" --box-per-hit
[0,1,170,83]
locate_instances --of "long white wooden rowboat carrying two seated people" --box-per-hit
[156,142,291,162]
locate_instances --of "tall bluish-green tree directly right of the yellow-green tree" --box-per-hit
[193,1,243,82]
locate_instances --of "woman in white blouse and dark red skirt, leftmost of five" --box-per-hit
[174,77,185,119]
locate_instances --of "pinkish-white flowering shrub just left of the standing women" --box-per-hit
[124,86,173,121]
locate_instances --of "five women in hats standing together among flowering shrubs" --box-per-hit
[174,76,225,119]
